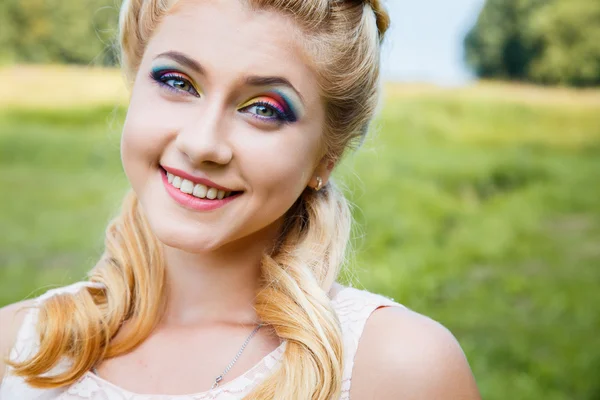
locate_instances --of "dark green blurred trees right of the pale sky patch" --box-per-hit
[465,0,600,86]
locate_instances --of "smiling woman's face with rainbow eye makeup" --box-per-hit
[121,0,328,252]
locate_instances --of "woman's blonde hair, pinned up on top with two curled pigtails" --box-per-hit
[8,0,390,400]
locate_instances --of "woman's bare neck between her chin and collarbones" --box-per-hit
[163,220,277,326]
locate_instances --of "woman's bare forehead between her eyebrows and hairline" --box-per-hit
[147,0,316,93]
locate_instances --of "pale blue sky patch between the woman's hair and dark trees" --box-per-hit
[382,0,484,86]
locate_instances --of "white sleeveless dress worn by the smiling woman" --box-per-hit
[0,282,404,400]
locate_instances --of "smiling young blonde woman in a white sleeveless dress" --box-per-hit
[0,0,479,400]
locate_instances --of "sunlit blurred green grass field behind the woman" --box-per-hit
[0,67,600,400]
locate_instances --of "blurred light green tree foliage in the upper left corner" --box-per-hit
[0,0,118,65]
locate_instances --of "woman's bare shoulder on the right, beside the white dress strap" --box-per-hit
[350,307,481,400]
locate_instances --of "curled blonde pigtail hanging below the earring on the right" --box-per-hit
[245,181,350,400]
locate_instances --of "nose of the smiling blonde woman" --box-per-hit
[175,105,233,166]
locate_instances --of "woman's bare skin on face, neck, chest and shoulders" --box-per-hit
[0,0,478,399]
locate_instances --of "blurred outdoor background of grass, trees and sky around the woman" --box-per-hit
[0,0,600,400]
